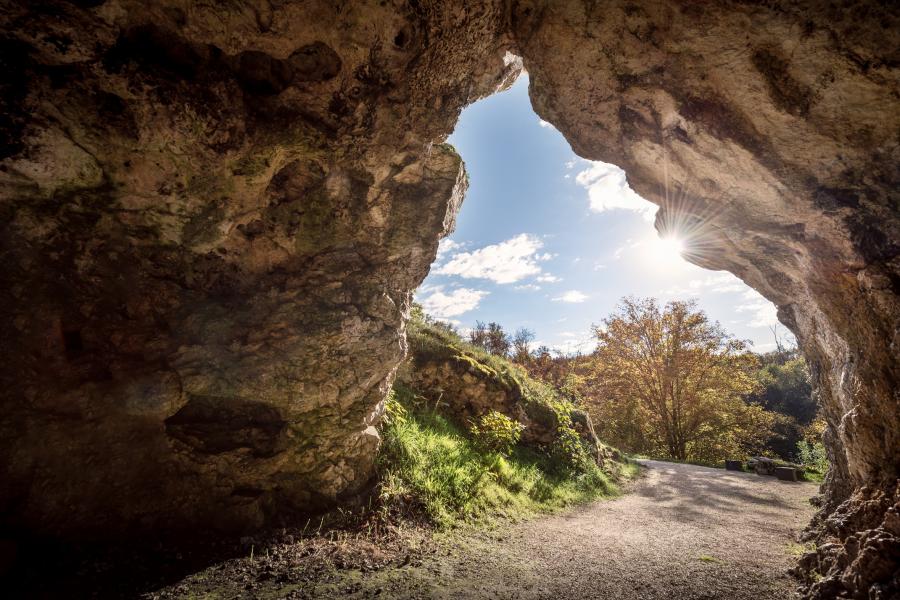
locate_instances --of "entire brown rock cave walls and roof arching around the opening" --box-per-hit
[0,0,900,598]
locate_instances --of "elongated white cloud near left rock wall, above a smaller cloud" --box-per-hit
[435,233,546,283]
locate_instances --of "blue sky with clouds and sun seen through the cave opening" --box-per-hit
[416,75,787,354]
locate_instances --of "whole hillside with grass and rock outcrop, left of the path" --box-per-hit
[378,320,637,526]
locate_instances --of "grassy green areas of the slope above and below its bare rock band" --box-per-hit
[378,323,638,527]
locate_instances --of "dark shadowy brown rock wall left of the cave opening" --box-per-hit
[0,0,518,536]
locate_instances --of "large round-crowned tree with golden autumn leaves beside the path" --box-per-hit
[591,298,774,462]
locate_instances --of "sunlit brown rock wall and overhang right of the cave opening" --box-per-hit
[512,1,900,598]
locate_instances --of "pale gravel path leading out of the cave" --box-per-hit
[144,461,817,600]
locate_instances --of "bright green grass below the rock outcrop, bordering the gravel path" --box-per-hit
[378,385,638,528]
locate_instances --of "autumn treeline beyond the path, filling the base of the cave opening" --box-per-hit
[414,298,827,471]
